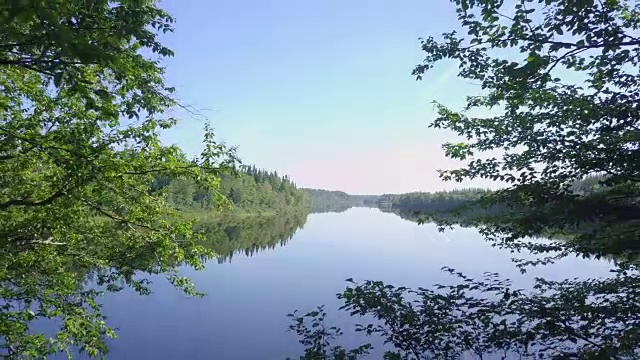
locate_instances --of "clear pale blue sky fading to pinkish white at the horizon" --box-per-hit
[161,0,498,194]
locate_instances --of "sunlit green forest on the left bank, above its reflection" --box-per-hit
[155,166,309,212]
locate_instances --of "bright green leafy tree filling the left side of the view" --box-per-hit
[0,0,235,359]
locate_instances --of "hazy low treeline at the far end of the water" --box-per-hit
[302,188,378,212]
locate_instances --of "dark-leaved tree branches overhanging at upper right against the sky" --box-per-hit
[414,0,640,253]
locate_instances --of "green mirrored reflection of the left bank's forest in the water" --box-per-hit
[197,213,307,263]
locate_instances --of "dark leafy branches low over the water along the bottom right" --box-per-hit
[292,268,640,360]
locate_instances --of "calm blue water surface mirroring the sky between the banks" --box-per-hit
[69,208,609,360]
